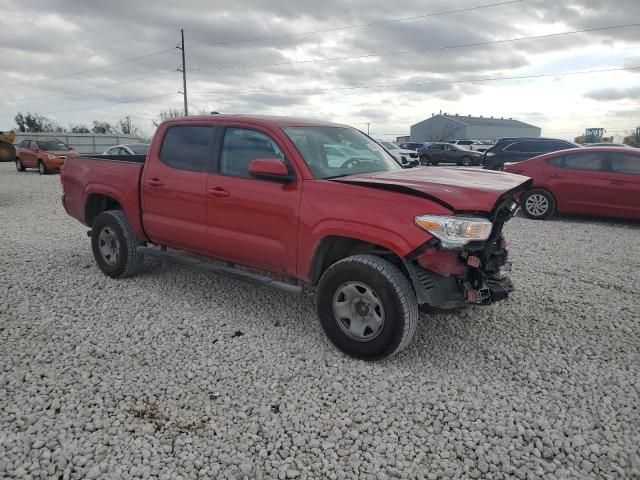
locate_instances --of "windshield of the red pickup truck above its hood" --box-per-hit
[283,127,402,179]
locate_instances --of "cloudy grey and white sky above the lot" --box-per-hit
[0,0,640,139]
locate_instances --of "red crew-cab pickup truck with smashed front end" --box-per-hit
[61,115,530,359]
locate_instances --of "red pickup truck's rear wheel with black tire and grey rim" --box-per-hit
[91,210,144,278]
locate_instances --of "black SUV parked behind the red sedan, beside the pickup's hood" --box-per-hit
[482,137,580,170]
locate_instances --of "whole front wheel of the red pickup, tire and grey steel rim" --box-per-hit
[316,255,418,360]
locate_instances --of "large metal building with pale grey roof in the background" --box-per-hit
[411,113,541,142]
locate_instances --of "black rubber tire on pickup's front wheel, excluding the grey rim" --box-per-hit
[316,255,418,360]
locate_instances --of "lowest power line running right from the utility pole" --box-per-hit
[192,66,640,95]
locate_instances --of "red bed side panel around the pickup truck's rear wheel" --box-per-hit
[62,157,146,239]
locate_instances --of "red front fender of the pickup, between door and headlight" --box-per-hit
[298,180,452,281]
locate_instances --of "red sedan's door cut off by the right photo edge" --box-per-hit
[609,152,640,219]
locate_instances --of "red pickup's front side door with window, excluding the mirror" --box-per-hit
[207,126,302,275]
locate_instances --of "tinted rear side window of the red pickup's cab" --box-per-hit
[160,125,217,172]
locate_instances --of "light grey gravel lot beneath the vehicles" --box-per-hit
[0,164,640,479]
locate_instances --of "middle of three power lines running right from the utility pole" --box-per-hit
[189,23,640,71]
